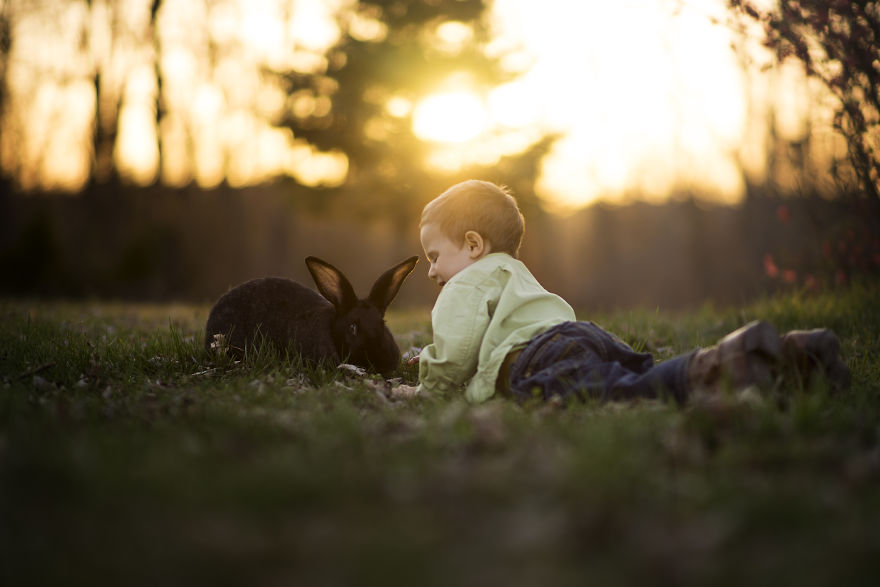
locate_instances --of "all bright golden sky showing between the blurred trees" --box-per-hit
[0,0,836,209]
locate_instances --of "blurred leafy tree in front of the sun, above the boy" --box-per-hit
[277,0,548,220]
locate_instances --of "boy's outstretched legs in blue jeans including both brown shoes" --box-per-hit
[510,321,850,403]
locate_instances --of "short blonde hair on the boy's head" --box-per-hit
[419,179,525,258]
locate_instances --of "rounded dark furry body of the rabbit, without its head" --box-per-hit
[205,277,339,364]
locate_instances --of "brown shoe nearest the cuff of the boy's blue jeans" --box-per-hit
[688,321,782,392]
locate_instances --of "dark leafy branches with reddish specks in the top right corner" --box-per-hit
[728,0,880,201]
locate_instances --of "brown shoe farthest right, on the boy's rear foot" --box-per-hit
[782,328,851,391]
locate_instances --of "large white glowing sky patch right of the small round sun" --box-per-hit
[484,0,760,208]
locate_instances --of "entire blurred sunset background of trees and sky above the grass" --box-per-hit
[0,0,880,309]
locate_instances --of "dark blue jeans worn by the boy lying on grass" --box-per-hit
[510,322,693,403]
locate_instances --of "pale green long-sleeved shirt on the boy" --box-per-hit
[419,253,575,403]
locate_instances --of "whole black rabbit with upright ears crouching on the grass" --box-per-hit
[205,257,419,374]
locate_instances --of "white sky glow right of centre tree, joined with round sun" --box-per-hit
[402,0,780,211]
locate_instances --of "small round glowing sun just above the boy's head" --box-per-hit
[413,91,488,143]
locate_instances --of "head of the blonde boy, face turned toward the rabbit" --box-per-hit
[419,179,524,286]
